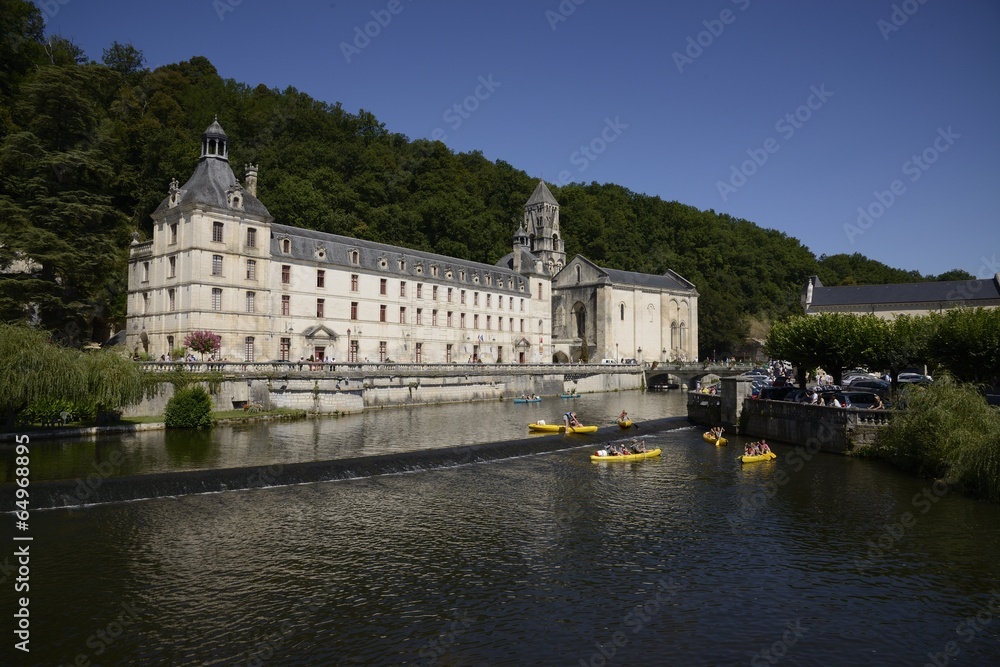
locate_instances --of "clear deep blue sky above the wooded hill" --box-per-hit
[45,0,1000,276]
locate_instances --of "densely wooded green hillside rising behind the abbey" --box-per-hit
[0,0,972,356]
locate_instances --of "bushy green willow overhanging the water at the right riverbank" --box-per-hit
[871,376,1000,502]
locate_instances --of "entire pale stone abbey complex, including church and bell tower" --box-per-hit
[126,121,698,363]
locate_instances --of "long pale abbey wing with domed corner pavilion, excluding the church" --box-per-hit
[126,122,551,363]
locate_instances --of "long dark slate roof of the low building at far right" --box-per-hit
[811,278,1000,308]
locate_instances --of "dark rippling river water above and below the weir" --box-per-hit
[3,392,1000,667]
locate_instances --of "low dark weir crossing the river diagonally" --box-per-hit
[27,417,690,509]
